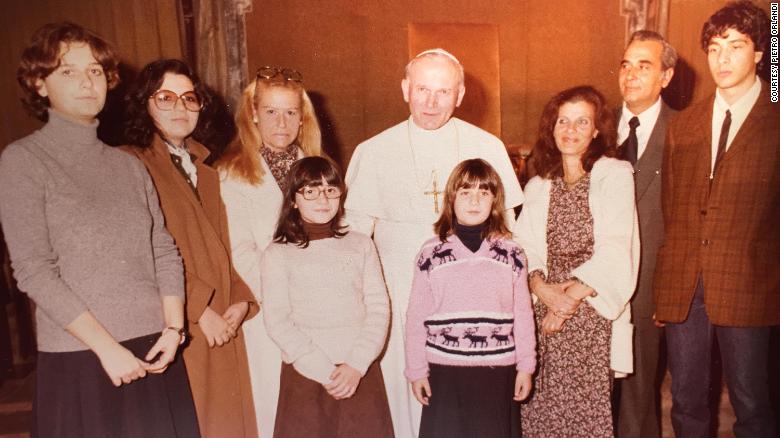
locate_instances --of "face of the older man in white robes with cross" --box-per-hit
[401,57,466,130]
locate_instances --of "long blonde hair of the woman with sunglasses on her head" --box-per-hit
[215,79,322,185]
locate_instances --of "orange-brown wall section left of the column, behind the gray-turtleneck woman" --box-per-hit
[0,0,182,148]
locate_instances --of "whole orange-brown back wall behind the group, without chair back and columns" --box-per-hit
[0,0,769,159]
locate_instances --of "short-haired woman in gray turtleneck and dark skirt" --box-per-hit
[0,23,198,437]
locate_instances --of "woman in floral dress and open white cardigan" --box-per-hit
[514,86,639,437]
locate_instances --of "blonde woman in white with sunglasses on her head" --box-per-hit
[216,67,321,438]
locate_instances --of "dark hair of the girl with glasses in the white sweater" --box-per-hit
[274,156,347,248]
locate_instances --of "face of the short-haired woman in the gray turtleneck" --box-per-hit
[37,42,108,123]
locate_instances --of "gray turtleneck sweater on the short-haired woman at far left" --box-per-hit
[0,110,184,352]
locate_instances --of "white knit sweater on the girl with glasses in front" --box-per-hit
[260,231,390,383]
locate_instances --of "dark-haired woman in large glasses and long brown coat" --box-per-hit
[125,59,257,437]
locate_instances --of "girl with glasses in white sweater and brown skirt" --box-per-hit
[261,157,393,438]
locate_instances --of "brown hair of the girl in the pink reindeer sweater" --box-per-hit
[433,158,512,242]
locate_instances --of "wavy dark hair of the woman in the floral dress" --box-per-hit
[533,85,617,178]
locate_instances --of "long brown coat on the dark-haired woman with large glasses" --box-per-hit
[124,136,258,437]
